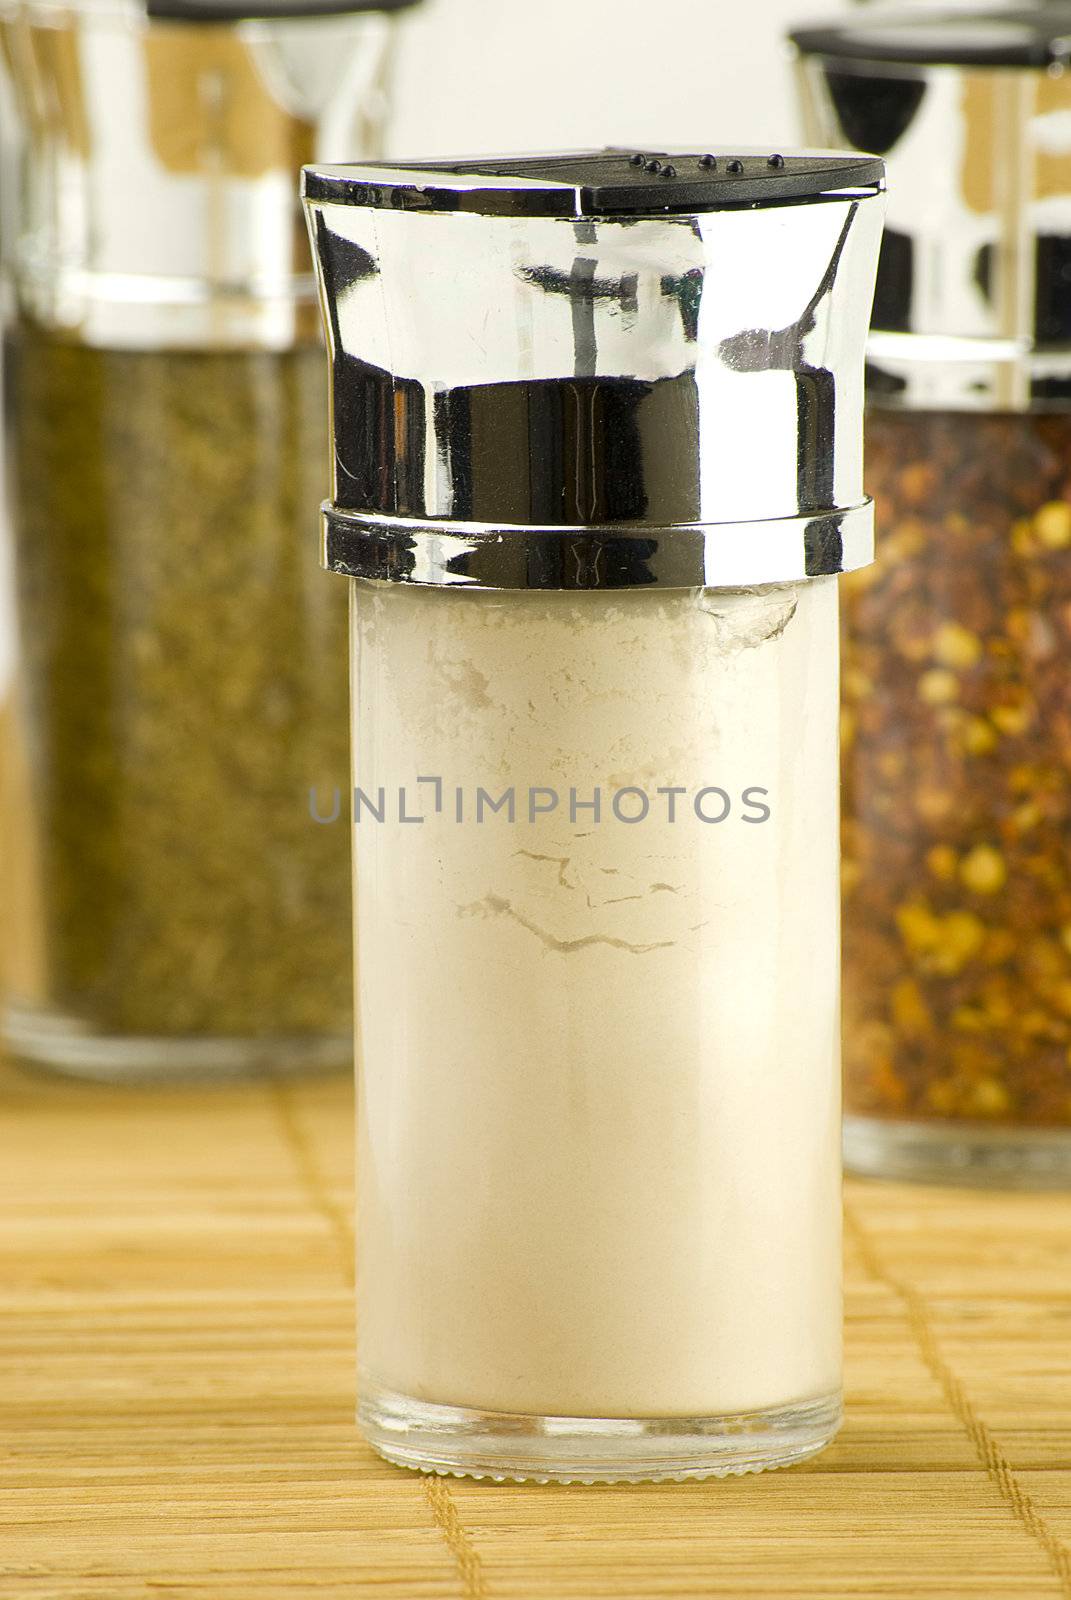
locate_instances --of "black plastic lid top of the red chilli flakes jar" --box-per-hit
[789,5,1071,70]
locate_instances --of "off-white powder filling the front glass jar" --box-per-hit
[354,578,840,1418]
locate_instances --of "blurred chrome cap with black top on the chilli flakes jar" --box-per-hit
[791,5,1071,410]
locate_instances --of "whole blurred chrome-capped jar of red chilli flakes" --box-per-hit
[792,5,1071,1186]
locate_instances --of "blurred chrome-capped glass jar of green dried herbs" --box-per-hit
[0,0,419,1078]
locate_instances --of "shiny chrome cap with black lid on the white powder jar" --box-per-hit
[304,150,884,589]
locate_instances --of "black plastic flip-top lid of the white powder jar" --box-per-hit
[303,149,885,216]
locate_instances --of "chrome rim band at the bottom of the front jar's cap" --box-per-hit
[316,499,874,589]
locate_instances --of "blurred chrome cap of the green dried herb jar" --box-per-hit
[0,0,408,349]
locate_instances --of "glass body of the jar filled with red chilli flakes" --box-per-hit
[842,410,1071,1184]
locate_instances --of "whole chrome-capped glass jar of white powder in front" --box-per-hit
[306,150,884,1482]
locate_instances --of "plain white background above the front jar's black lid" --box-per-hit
[391,0,848,157]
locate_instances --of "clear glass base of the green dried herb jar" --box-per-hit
[0,1005,354,1083]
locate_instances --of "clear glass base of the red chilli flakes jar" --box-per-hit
[844,1115,1071,1189]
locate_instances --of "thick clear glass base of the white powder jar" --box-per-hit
[357,1379,842,1483]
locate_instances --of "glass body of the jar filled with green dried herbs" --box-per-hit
[5,323,351,1077]
